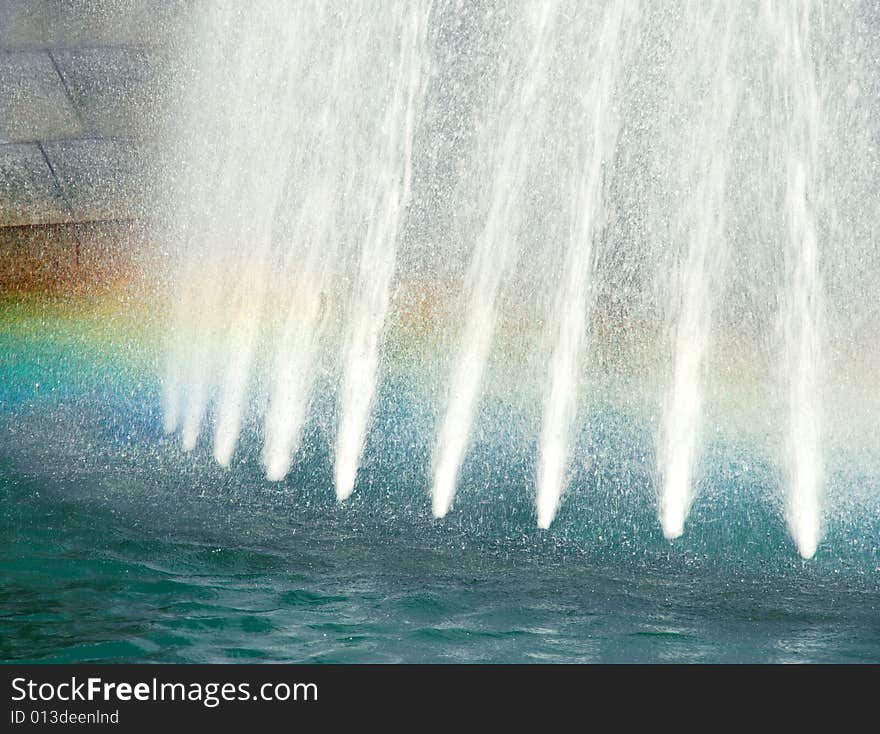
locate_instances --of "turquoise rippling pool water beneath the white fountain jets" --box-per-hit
[0,324,880,662]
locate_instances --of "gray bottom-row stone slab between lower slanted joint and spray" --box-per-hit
[45,140,155,222]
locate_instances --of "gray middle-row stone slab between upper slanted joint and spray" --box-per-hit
[53,47,169,138]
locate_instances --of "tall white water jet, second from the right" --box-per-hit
[657,3,736,538]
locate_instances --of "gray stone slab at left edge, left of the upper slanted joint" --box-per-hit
[0,51,83,143]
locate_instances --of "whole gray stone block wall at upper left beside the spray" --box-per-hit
[0,0,180,231]
